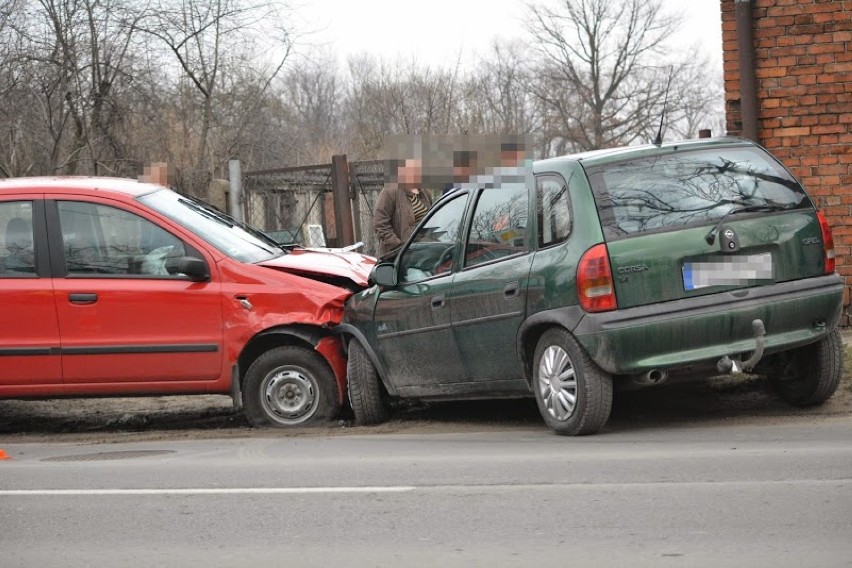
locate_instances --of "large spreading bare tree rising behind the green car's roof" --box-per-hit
[528,0,677,150]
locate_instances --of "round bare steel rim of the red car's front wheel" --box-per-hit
[263,367,319,424]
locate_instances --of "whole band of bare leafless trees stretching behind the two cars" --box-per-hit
[0,0,723,185]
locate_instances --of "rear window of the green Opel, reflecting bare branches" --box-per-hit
[587,147,812,239]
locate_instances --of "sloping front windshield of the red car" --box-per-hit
[139,189,283,262]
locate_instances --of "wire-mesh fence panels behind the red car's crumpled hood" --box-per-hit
[242,157,384,254]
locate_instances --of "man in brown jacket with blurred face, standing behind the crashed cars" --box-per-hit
[373,158,432,257]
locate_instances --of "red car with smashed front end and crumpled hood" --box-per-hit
[0,178,374,426]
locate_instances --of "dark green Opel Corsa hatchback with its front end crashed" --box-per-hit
[337,138,843,435]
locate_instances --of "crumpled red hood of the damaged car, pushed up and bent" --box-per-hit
[258,248,376,287]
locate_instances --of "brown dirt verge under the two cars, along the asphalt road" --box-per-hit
[0,347,852,443]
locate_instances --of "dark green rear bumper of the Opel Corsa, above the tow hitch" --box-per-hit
[573,274,843,374]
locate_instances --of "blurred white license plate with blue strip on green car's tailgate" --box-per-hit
[683,252,772,290]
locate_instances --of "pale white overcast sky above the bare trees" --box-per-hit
[291,0,722,74]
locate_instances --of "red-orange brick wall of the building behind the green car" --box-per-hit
[720,0,852,326]
